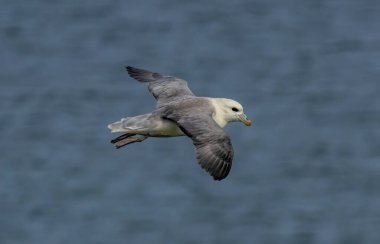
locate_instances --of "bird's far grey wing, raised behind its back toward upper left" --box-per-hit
[126,66,194,106]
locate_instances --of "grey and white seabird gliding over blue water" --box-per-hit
[108,66,252,181]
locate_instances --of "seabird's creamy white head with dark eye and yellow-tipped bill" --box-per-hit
[214,98,252,127]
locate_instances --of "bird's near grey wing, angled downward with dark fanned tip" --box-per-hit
[166,108,234,180]
